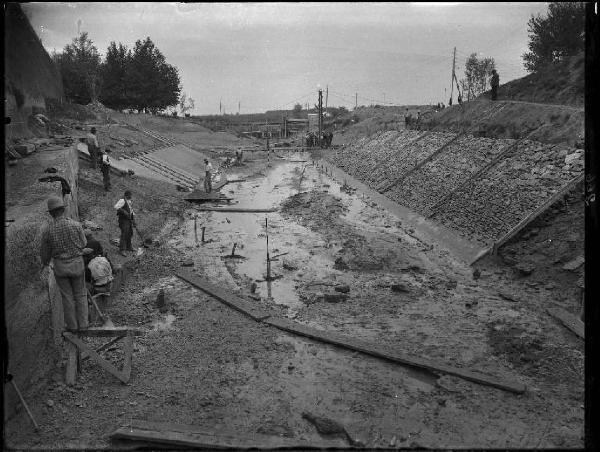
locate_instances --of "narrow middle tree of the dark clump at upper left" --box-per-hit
[100,41,131,110]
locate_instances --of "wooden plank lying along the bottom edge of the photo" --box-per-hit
[111,420,331,450]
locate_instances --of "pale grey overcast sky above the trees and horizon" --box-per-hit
[22,2,548,114]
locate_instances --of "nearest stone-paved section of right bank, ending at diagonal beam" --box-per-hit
[432,140,583,244]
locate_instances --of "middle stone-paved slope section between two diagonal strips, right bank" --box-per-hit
[386,135,516,215]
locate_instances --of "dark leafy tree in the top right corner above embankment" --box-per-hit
[523,2,585,72]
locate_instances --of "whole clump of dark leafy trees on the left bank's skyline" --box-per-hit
[52,32,185,113]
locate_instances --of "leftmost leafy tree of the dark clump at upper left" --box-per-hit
[53,32,100,104]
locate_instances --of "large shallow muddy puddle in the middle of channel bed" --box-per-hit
[169,152,434,315]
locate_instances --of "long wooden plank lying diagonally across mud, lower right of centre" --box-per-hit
[264,317,525,394]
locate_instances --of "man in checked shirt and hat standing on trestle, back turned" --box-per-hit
[40,197,88,332]
